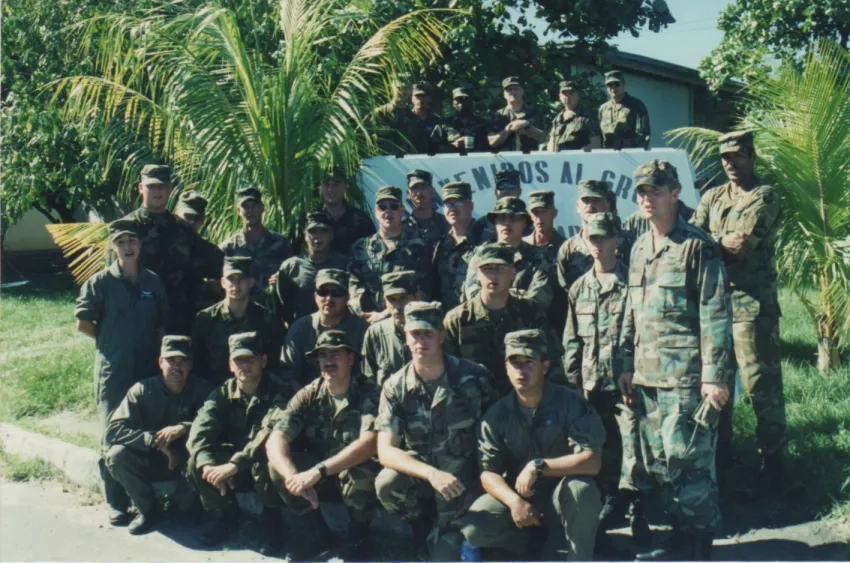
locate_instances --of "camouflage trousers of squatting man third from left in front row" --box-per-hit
[269,452,381,524]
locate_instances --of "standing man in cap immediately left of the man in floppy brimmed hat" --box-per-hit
[431,182,479,311]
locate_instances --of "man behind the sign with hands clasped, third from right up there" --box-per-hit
[487,76,549,152]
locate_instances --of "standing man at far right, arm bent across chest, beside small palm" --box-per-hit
[691,132,787,484]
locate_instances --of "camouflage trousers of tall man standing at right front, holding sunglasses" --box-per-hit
[635,385,720,532]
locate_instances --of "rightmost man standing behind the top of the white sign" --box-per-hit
[599,70,650,150]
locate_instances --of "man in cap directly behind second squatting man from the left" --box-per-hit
[192,256,283,385]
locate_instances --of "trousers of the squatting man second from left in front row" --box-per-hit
[189,447,282,515]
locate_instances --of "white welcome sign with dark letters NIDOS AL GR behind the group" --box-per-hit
[357,148,699,236]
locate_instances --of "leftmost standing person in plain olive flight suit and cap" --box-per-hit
[74,219,168,526]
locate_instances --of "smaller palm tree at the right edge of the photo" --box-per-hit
[669,42,850,374]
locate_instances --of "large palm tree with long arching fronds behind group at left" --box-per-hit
[46,0,456,280]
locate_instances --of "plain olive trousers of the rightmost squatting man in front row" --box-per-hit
[459,477,602,561]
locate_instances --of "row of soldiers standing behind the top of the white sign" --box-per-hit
[375,70,650,159]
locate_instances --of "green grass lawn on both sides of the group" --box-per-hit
[0,280,850,517]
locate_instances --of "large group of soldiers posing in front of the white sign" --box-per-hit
[75,126,786,560]
